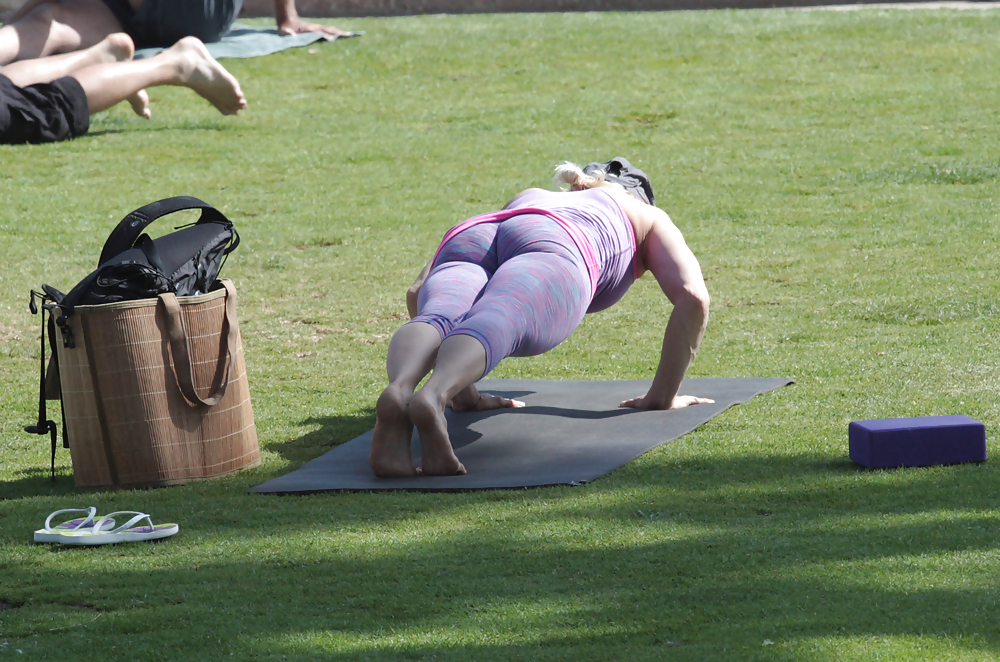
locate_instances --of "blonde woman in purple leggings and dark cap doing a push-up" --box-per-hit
[369,158,712,477]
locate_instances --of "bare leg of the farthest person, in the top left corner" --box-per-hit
[0,0,122,66]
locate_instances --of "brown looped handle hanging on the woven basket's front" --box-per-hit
[159,278,240,407]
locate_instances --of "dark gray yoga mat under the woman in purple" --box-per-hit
[250,378,792,494]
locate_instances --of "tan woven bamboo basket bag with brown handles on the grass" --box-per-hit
[56,280,260,487]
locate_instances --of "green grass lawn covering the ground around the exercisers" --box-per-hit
[0,9,1000,661]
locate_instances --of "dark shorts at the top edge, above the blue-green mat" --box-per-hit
[103,0,243,48]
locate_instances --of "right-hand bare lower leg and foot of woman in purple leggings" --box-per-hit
[408,335,486,476]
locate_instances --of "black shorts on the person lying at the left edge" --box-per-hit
[0,74,90,145]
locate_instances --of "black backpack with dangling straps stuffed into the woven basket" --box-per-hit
[25,195,240,480]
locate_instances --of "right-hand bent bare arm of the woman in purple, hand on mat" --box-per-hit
[621,200,712,409]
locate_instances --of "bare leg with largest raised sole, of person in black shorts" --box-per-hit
[73,37,247,117]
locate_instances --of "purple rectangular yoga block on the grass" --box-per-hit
[848,415,986,469]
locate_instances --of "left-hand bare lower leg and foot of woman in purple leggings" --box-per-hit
[368,322,441,478]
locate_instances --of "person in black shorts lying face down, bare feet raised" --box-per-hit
[0,33,247,144]
